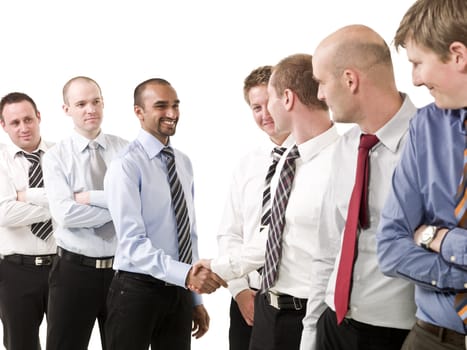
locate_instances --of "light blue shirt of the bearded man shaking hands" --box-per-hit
[104,130,201,305]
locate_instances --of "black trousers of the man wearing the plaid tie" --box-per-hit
[250,292,306,350]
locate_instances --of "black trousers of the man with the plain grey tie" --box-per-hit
[47,256,114,350]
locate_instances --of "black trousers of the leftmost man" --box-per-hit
[0,260,50,350]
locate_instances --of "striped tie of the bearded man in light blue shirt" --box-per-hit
[161,147,192,264]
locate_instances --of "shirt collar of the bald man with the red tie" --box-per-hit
[376,93,417,153]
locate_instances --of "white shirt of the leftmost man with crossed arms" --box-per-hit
[0,140,56,255]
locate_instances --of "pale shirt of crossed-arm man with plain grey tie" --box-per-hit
[43,131,128,257]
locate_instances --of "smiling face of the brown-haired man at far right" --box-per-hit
[406,39,467,109]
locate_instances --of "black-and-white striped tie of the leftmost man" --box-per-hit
[21,151,53,241]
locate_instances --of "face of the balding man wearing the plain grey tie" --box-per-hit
[63,79,104,140]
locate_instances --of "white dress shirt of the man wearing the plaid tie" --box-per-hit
[211,126,339,298]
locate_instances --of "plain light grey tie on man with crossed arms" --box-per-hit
[88,140,115,240]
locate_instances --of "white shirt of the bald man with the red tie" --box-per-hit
[300,95,416,350]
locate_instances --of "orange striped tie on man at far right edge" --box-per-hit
[454,119,467,325]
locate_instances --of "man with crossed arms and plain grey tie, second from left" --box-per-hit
[43,77,128,350]
